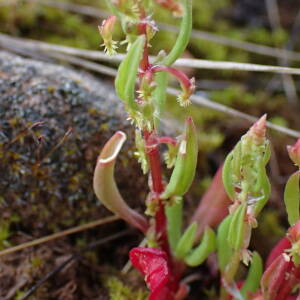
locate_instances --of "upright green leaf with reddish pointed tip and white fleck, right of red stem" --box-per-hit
[160,118,198,199]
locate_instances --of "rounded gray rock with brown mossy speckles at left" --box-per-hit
[0,52,147,231]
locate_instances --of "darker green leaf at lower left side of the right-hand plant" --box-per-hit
[217,215,233,273]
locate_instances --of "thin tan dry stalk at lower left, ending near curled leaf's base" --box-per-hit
[0,216,120,257]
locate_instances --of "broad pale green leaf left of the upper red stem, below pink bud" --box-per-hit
[115,35,145,110]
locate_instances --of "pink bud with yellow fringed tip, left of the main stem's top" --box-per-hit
[98,16,118,56]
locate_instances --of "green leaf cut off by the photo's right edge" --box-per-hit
[284,171,300,226]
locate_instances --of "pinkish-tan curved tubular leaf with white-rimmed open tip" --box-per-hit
[93,131,148,232]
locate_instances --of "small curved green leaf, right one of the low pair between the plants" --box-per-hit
[184,227,216,267]
